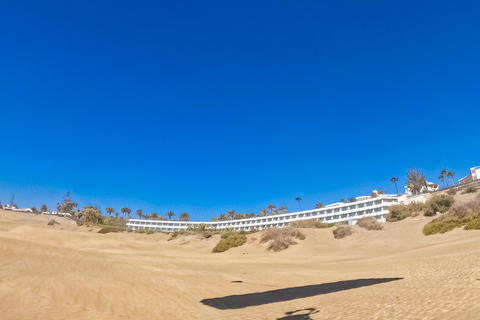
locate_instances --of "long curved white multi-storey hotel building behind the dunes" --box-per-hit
[127,194,398,232]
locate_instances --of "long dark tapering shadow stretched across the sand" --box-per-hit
[201,278,403,310]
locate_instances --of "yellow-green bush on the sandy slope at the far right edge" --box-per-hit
[423,195,480,236]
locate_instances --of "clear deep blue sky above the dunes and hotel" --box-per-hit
[0,0,480,220]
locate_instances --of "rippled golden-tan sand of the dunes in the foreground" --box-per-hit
[0,206,480,320]
